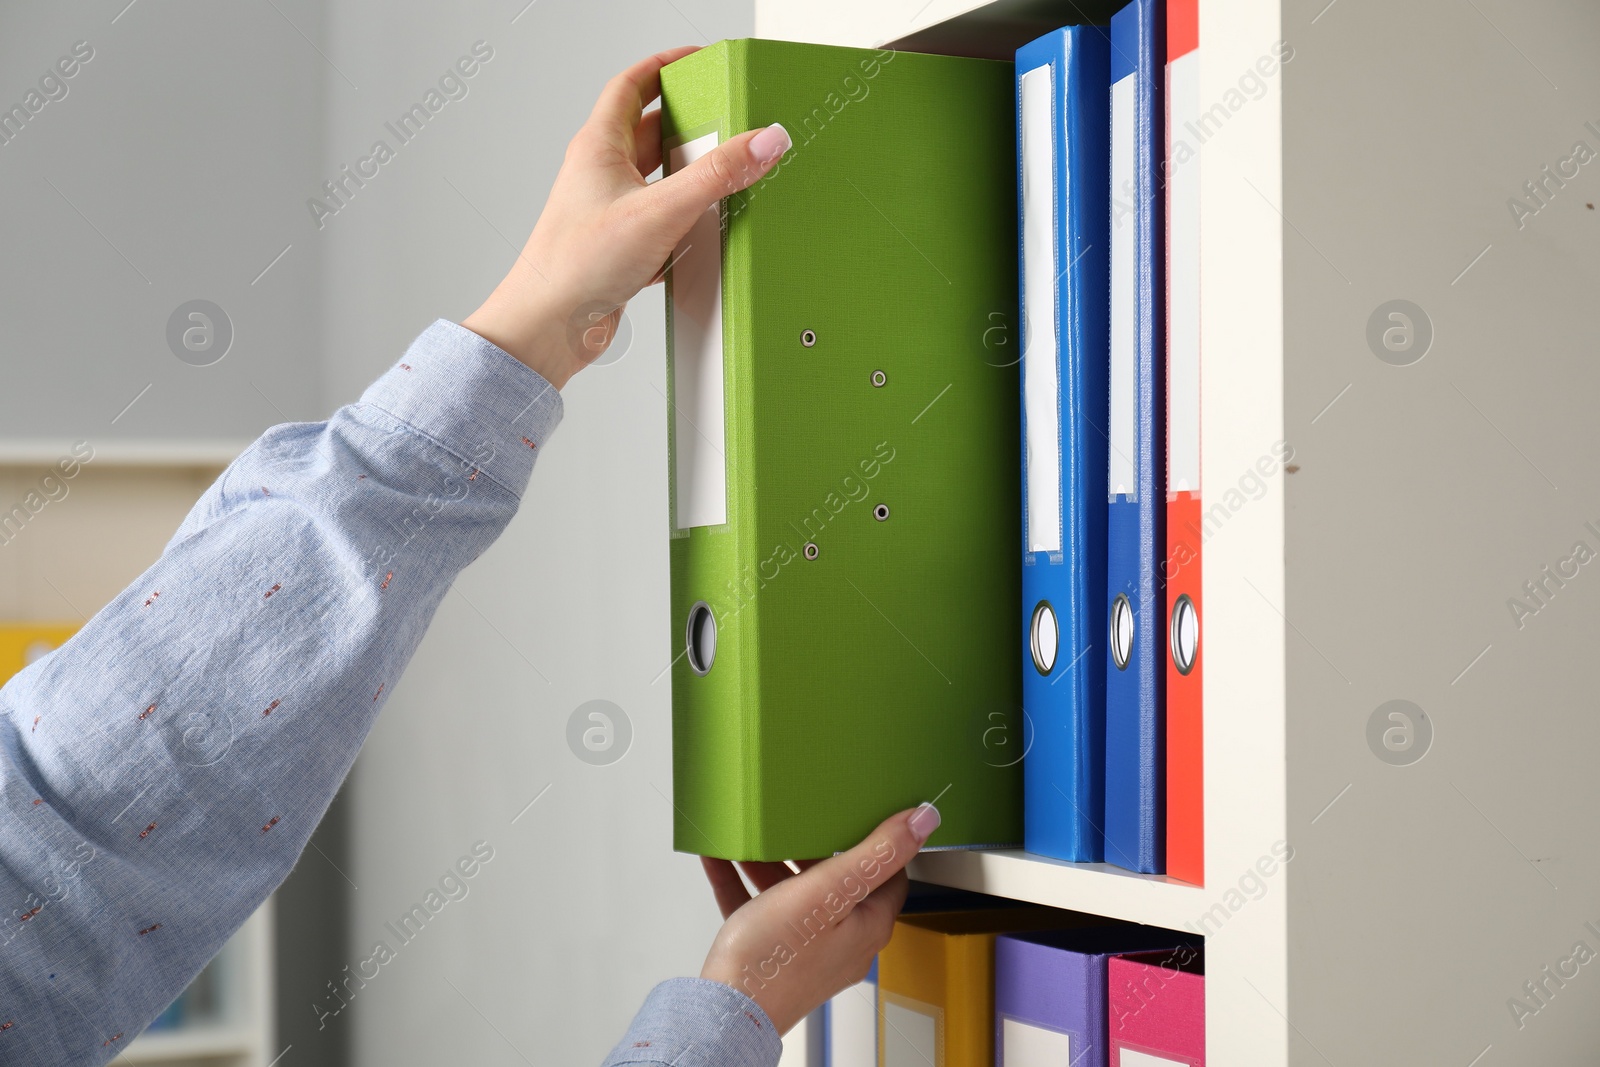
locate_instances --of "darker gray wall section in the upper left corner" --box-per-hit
[0,0,326,446]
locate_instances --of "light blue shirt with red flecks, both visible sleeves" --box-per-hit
[0,320,778,1067]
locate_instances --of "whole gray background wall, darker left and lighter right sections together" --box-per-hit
[0,0,752,1067]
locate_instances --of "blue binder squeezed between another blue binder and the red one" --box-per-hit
[1101,0,1166,873]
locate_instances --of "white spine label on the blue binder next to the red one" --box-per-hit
[1107,74,1139,501]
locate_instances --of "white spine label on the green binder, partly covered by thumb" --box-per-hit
[669,133,728,530]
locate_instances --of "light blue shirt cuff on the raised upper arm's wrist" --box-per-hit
[362,318,562,496]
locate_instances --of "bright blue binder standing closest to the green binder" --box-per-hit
[1016,26,1110,862]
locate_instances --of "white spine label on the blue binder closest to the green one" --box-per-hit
[1021,62,1061,553]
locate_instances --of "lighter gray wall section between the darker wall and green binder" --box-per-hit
[315,0,750,1067]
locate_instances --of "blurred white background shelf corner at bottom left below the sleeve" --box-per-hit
[117,901,278,1067]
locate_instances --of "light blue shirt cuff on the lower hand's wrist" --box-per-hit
[605,977,784,1067]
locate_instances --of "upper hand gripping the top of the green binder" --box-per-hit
[461,48,790,389]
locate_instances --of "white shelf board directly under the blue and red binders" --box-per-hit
[910,849,1213,929]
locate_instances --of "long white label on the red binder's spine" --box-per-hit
[1166,51,1200,496]
